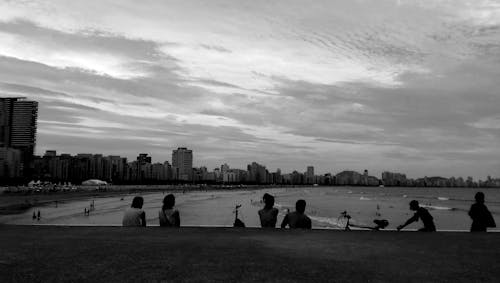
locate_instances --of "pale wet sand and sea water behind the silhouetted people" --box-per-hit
[0,187,500,231]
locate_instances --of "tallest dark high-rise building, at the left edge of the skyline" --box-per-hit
[0,97,38,176]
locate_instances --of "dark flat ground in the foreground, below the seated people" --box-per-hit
[0,226,500,282]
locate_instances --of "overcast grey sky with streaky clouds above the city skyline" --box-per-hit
[0,0,500,179]
